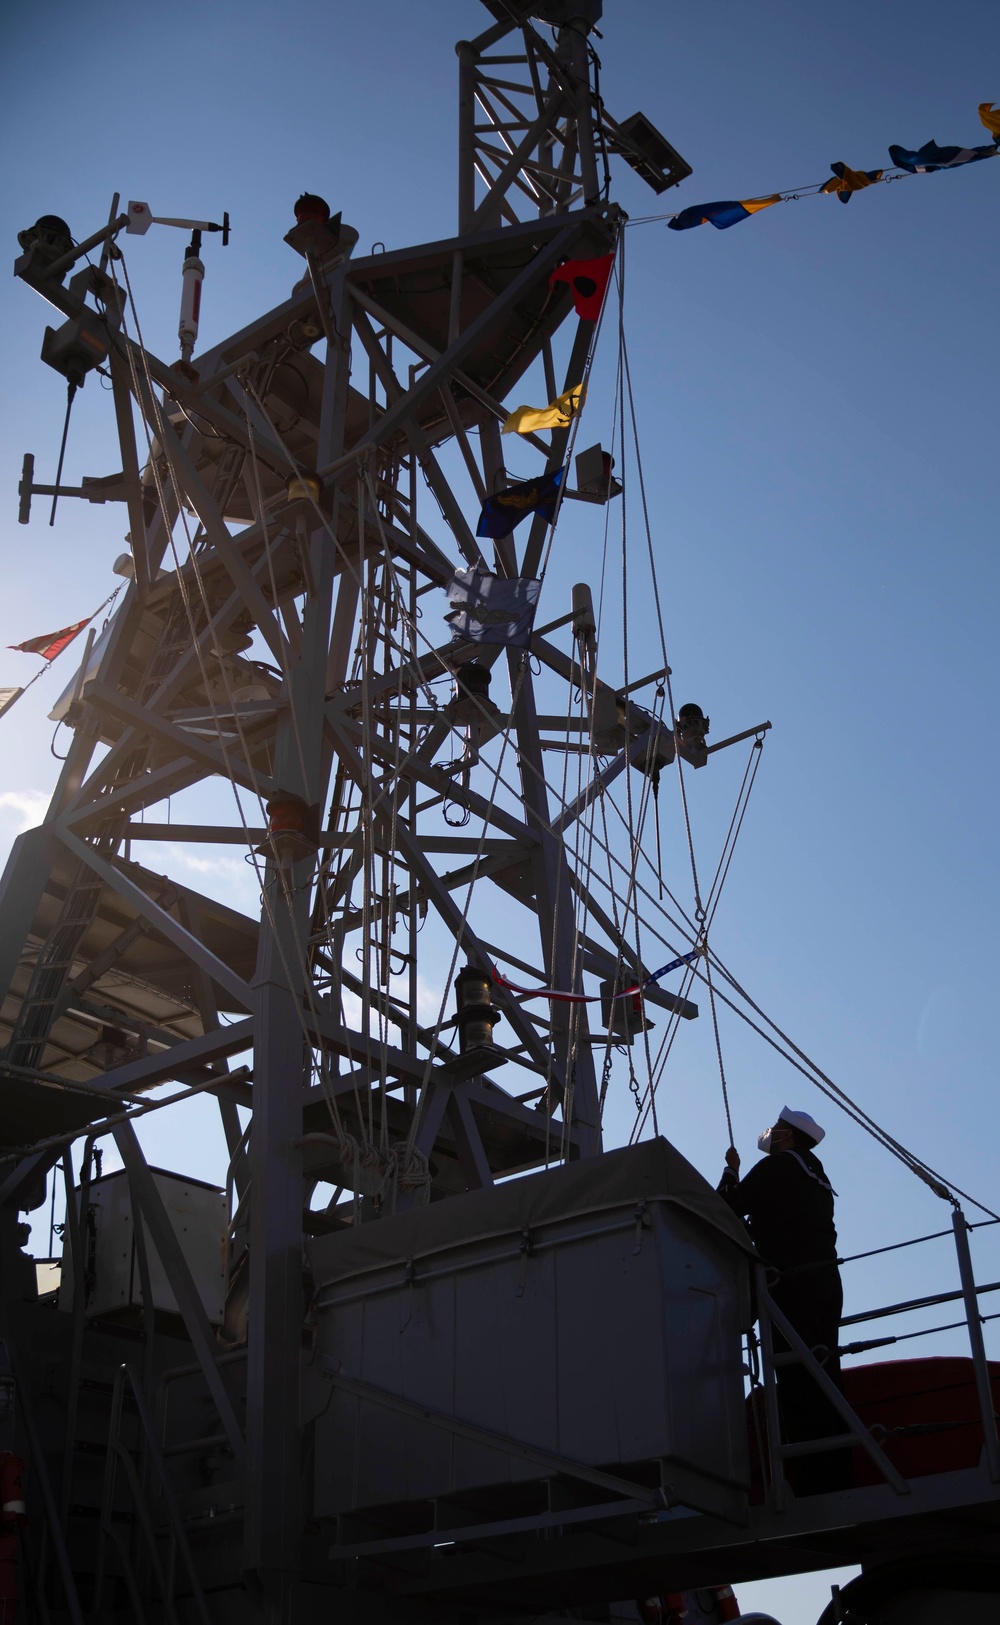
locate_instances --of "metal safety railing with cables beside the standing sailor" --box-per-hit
[748,1206,1000,1511]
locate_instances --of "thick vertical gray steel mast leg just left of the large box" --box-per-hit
[244,268,350,1599]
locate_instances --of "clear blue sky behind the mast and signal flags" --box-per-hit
[0,0,1000,1625]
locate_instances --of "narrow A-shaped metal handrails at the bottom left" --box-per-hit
[93,1365,211,1625]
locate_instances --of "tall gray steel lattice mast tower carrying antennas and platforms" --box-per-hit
[0,0,694,1617]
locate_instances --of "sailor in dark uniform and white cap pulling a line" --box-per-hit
[719,1107,850,1495]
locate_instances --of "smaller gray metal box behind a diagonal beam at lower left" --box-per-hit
[59,1168,228,1326]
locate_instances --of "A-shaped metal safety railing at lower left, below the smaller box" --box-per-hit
[91,1365,211,1625]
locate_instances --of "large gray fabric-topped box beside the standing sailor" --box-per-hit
[309,1139,753,1516]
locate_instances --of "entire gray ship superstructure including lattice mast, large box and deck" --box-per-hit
[0,0,1000,1622]
